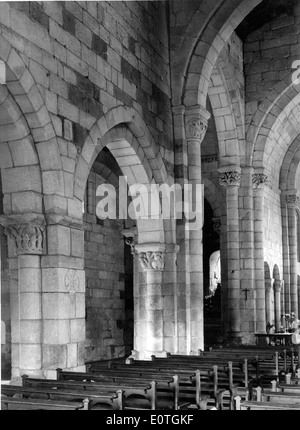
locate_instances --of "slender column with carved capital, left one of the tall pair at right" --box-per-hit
[219,166,241,341]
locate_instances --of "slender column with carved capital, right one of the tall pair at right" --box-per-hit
[252,169,268,333]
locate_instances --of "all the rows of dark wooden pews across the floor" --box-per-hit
[1,347,300,410]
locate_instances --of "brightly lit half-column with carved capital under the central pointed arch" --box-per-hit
[134,244,166,360]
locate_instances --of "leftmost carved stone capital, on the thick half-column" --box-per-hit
[4,223,46,255]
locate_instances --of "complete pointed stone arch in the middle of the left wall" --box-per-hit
[74,106,169,243]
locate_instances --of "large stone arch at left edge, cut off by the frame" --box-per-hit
[0,35,65,212]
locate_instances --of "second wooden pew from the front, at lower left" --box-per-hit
[1,384,124,410]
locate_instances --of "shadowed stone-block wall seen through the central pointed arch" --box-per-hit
[84,172,130,360]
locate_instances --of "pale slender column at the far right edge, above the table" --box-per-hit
[286,194,300,318]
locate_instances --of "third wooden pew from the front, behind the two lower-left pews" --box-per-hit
[22,375,156,410]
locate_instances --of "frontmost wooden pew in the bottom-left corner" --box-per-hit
[1,394,89,411]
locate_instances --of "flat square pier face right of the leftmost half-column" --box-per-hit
[41,220,86,378]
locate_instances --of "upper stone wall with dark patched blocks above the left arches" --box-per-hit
[0,1,173,165]
